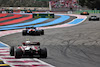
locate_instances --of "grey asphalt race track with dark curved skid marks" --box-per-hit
[0,14,100,67]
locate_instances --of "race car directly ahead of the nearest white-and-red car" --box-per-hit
[22,27,44,35]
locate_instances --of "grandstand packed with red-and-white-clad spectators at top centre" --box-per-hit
[50,0,79,11]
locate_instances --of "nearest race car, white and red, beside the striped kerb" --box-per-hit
[10,41,47,58]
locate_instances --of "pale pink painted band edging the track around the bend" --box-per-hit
[0,14,87,37]
